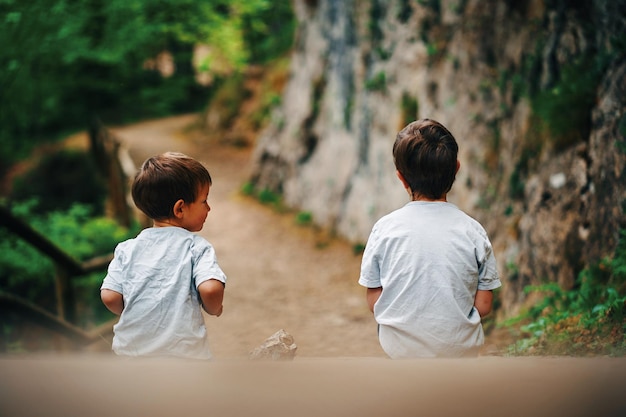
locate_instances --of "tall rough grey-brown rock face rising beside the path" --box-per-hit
[251,0,626,313]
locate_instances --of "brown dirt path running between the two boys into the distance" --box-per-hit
[113,116,384,358]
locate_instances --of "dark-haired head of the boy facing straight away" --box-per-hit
[393,119,459,200]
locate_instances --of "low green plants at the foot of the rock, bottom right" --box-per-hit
[505,230,626,355]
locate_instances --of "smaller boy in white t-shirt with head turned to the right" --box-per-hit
[100,152,226,359]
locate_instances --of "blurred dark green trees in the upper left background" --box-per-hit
[0,0,270,172]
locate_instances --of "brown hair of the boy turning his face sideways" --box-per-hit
[131,152,212,220]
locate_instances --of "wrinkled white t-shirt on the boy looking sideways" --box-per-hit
[101,227,226,359]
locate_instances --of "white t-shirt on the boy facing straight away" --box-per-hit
[359,201,501,358]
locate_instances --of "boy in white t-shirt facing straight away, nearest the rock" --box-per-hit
[359,119,501,359]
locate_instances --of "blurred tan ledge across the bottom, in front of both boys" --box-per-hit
[0,355,626,417]
